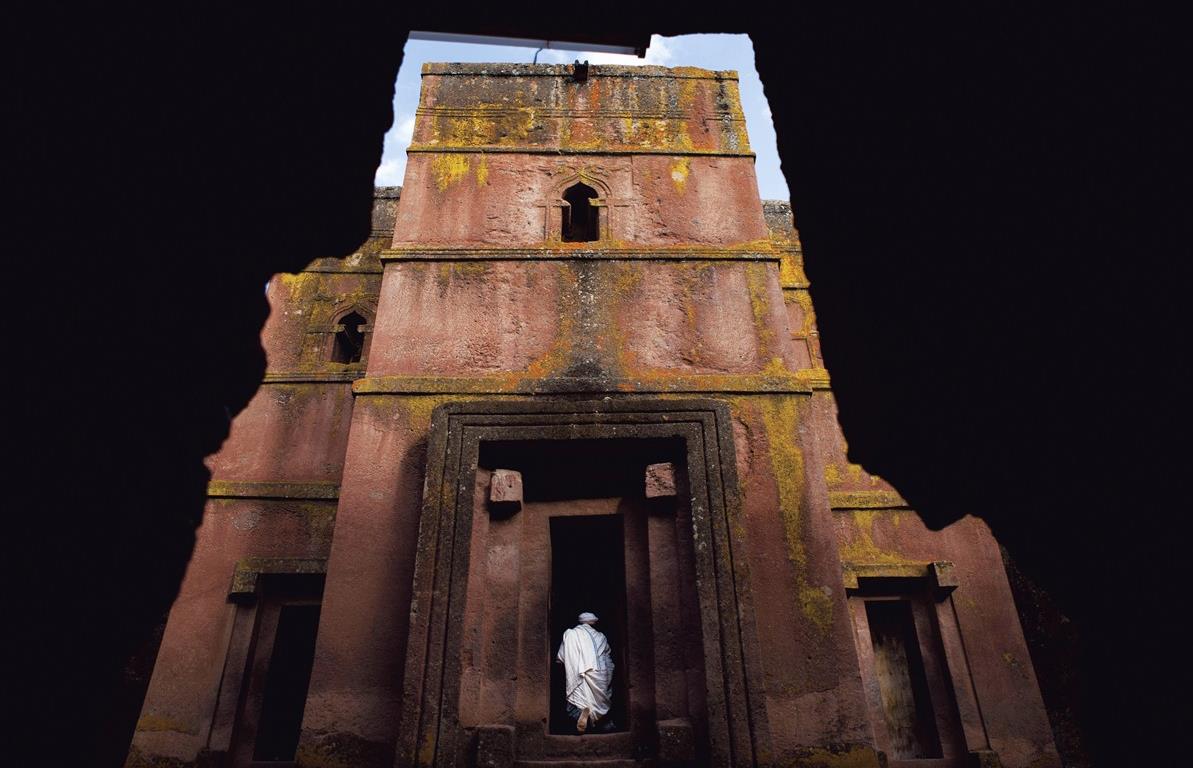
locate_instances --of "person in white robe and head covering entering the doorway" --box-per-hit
[555,611,613,733]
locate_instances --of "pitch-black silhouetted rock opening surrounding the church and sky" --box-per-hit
[11,2,1193,767]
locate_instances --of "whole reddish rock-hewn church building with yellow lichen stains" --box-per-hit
[128,64,1059,768]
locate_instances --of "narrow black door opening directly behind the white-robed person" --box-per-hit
[550,514,629,735]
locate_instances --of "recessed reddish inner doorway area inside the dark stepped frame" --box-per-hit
[470,436,704,762]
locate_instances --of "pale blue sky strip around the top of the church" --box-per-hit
[377,35,789,200]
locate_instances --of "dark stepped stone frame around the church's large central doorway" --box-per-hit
[395,398,765,767]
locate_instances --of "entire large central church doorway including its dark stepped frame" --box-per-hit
[396,401,753,768]
